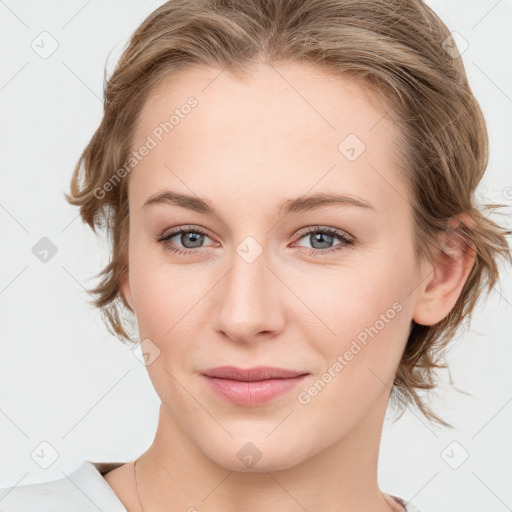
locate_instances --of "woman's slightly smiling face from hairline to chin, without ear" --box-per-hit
[122,64,420,471]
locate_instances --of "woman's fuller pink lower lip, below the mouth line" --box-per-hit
[204,375,307,405]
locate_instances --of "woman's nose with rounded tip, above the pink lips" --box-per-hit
[214,244,284,343]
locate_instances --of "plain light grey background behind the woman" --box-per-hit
[0,0,512,512]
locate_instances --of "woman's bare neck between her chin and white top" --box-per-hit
[133,392,401,512]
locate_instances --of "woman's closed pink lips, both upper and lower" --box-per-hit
[202,366,309,406]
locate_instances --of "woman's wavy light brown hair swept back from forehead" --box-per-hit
[66,0,512,426]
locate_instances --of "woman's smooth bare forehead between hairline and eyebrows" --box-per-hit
[130,63,407,216]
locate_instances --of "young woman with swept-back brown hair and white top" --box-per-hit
[0,0,510,512]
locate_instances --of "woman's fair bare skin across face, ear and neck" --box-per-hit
[105,62,472,512]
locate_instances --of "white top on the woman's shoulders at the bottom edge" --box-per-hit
[0,460,420,512]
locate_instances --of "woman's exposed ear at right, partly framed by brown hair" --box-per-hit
[413,214,476,325]
